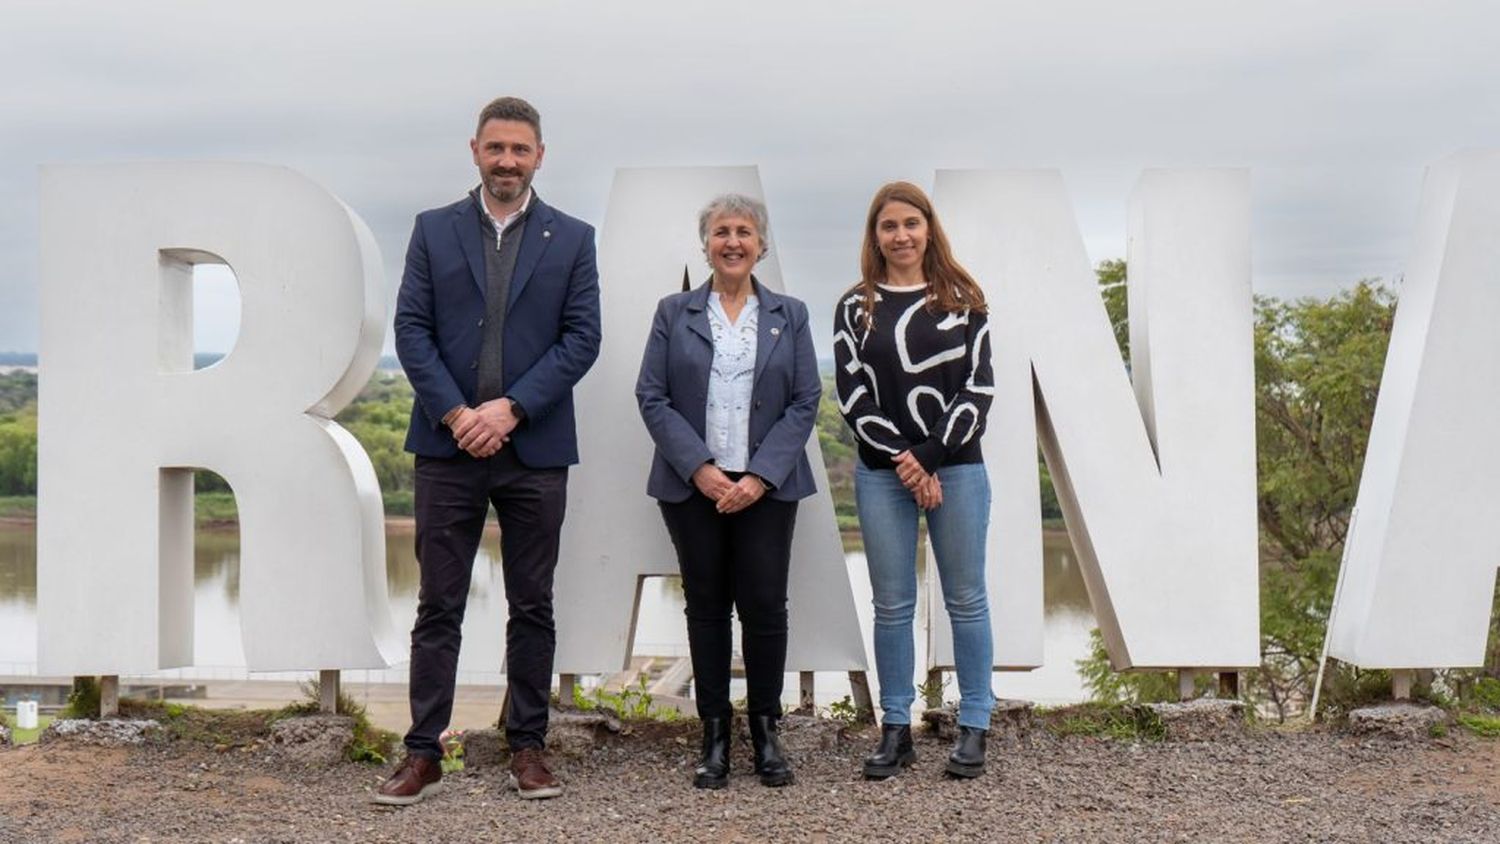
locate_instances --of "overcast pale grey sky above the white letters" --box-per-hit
[0,0,1500,351]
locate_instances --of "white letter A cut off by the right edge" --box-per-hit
[1329,151,1500,669]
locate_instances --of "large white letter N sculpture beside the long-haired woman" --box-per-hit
[933,169,1260,669]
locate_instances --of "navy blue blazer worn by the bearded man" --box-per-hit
[396,193,600,469]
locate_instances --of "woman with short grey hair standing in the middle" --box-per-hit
[636,193,822,789]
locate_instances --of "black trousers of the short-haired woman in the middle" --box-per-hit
[660,492,797,718]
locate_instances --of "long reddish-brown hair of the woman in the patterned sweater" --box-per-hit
[858,181,987,331]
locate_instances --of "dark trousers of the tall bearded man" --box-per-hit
[407,447,567,757]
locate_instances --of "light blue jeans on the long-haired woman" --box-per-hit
[854,463,995,730]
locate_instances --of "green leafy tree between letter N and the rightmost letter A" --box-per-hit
[1256,280,1395,718]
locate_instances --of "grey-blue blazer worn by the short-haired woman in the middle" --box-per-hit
[636,279,824,502]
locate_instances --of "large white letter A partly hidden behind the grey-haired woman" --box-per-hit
[557,166,866,673]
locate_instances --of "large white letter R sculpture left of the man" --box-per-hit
[38,163,390,675]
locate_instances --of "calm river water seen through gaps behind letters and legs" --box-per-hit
[0,523,1094,703]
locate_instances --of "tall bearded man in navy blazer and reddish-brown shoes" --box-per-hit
[375,97,600,805]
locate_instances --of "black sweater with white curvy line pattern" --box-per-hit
[834,285,995,472]
